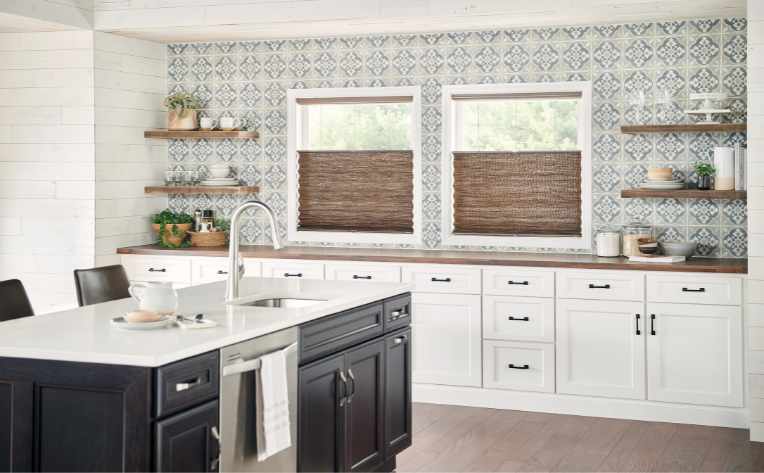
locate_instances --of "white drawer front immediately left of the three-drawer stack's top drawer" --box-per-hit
[402,264,480,294]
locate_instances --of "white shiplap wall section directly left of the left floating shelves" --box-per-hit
[95,33,167,266]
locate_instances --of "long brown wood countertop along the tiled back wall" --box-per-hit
[117,245,748,274]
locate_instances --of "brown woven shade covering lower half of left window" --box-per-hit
[298,151,414,233]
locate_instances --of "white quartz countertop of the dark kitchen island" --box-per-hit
[0,278,411,367]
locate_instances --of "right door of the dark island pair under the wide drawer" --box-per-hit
[345,339,385,471]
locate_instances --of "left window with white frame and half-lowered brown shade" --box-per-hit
[288,87,421,244]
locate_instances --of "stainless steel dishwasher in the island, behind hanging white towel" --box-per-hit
[219,327,299,472]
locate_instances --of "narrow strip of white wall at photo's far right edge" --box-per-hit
[745,0,764,442]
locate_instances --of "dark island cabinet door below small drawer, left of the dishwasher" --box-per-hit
[154,401,220,472]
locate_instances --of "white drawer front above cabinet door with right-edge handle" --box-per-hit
[557,270,645,301]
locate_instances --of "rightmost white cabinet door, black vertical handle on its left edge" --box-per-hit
[647,303,743,407]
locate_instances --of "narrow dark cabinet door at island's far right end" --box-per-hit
[385,328,411,457]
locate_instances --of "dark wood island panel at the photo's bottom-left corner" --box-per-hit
[0,379,34,471]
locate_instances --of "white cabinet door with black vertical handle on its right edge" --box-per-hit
[557,300,646,399]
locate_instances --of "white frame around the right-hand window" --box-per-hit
[441,81,592,250]
